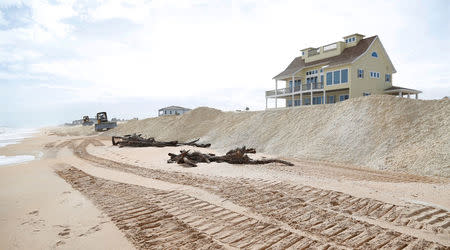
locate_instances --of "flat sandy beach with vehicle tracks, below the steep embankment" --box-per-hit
[0,126,450,249]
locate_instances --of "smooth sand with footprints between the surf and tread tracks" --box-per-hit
[0,130,133,249]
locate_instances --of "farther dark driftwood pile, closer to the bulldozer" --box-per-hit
[111,134,211,148]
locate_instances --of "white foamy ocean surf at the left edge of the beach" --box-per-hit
[0,127,37,166]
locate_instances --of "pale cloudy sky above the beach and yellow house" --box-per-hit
[0,0,450,127]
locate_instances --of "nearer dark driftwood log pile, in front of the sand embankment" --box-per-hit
[167,146,294,167]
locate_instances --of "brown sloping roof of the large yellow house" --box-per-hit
[273,36,377,79]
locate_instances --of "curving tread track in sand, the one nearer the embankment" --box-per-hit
[54,140,449,248]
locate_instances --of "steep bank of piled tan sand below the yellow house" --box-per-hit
[105,96,450,177]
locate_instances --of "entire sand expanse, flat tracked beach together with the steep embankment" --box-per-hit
[0,97,450,249]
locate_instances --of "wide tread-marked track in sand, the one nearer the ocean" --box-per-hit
[56,167,334,249]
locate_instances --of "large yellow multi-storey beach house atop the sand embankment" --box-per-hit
[266,34,422,109]
